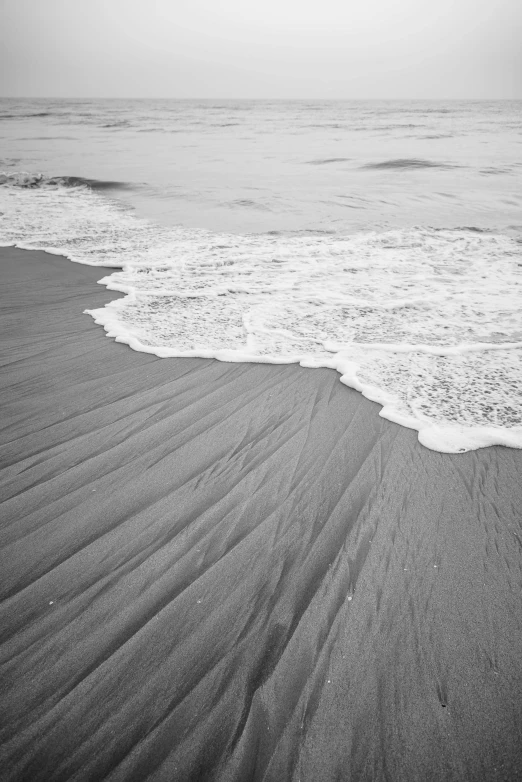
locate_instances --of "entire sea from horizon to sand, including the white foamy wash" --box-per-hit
[0,99,522,453]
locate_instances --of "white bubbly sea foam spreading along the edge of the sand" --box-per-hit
[0,174,522,453]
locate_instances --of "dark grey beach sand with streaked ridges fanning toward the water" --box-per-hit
[0,249,522,782]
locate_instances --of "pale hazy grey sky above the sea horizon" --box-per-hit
[0,0,522,98]
